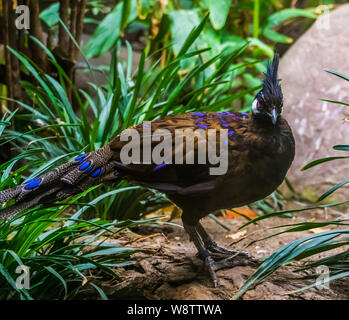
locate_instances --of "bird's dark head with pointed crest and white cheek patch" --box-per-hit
[252,53,283,125]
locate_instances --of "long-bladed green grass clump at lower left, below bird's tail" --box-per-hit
[0,112,162,300]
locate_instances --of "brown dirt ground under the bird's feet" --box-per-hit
[84,204,349,300]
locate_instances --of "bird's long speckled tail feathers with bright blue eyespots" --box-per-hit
[0,146,118,220]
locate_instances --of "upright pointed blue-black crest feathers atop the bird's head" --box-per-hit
[262,52,283,107]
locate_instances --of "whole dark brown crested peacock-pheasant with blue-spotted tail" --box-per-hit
[0,54,295,286]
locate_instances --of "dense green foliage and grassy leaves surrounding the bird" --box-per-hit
[0,0,348,299]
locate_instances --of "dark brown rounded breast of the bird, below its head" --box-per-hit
[217,122,294,207]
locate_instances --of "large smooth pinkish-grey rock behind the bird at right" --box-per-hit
[279,4,349,200]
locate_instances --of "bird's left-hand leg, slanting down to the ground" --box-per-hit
[183,221,218,288]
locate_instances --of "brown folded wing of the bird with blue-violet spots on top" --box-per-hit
[110,112,247,194]
